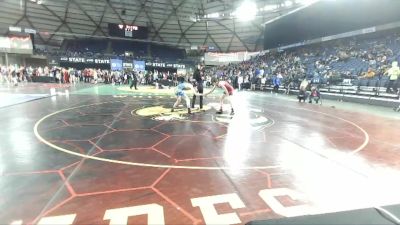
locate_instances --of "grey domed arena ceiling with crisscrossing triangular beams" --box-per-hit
[0,0,312,52]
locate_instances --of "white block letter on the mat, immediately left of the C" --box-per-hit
[191,193,246,224]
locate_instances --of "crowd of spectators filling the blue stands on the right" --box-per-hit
[206,29,400,92]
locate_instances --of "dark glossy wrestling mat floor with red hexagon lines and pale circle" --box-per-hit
[0,84,400,224]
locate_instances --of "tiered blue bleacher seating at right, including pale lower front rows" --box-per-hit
[222,30,400,105]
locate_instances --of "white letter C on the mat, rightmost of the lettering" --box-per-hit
[258,188,311,217]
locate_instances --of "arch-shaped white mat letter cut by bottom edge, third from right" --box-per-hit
[103,204,165,225]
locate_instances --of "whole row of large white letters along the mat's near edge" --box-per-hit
[10,188,312,225]
